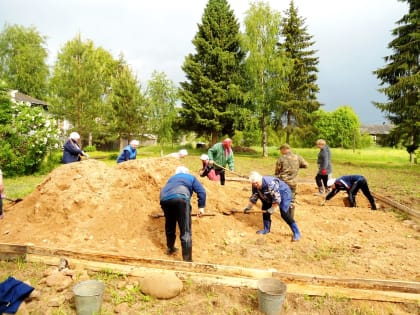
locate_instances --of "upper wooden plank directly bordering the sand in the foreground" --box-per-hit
[0,244,420,294]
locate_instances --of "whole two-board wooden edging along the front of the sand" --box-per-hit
[0,244,420,302]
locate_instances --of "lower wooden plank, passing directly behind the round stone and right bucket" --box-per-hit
[28,254,420,303]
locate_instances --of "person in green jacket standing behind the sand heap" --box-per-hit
[207,138,234,185]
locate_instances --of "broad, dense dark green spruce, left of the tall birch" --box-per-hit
[179,0,244,143]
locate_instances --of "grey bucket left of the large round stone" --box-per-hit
[73,280,105,315]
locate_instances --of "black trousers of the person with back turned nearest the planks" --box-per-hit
[160,199,192,253]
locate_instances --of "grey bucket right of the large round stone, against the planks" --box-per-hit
[257,278,287,315]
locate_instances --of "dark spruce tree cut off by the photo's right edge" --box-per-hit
[374,0,420,161]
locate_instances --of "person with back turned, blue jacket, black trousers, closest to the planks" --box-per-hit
[160,166,206,261]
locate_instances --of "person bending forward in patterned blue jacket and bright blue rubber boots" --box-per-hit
[244,172,301,242]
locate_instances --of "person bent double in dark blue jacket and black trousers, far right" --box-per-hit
[323,175,376,210]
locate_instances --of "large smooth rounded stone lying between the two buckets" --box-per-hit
[140,272,183,299]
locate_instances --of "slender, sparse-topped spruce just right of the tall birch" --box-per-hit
[277,1,320,143]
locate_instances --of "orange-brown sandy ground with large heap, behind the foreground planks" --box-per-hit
[0,158,420,281]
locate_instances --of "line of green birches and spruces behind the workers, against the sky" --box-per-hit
[0,0,420,174]
